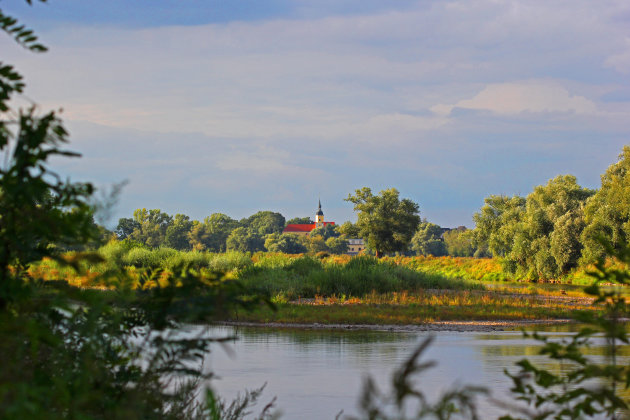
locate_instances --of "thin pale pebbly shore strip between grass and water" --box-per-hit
[218,319,574,332]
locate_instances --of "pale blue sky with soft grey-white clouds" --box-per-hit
[0,0,630,227]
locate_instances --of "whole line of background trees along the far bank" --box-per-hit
[115,146,630,274]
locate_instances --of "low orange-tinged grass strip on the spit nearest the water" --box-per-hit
[230,290,593,325]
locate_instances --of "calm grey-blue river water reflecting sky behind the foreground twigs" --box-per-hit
[199,325,630,420]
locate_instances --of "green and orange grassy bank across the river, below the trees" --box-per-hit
[29,244,627,329]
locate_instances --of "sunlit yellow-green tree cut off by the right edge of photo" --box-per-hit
[581,146,630,263]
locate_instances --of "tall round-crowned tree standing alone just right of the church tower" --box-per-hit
[346,187,420,257]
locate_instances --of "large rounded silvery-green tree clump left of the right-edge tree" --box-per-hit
[473,175,594,280]
